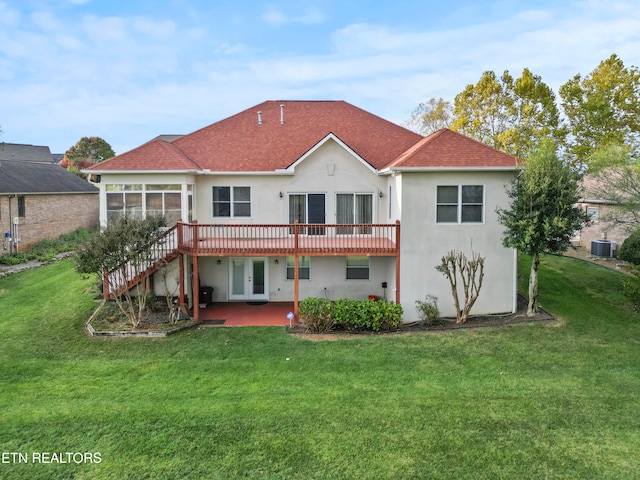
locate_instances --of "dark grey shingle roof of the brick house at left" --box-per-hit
[0,143,98,195]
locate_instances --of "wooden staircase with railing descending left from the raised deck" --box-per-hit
[103,226,178,300]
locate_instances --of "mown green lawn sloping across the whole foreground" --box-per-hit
[0,257,640,480]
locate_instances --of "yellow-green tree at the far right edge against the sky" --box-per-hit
[559,54,640,170]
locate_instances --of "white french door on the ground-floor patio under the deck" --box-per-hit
[229,257,269,300]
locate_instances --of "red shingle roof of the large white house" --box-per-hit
[88,101,515,173]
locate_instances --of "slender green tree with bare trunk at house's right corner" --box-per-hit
[497,139,588,316]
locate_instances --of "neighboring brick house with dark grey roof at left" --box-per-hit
[0,143,99,253]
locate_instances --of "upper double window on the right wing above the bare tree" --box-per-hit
[436,185,484,223]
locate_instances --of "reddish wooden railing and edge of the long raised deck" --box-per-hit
[177,222,400,256]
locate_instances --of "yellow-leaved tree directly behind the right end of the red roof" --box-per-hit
[452,69,565,158]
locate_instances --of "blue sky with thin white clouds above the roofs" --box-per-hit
[0,0,640,153]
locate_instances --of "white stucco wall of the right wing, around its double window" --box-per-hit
[400,172,515,321]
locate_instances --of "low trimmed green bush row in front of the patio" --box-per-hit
[300,297,402,333]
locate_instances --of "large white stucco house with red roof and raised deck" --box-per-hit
[87,101,516,321]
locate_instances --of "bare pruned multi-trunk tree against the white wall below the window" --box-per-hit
[436,250,484,323]
